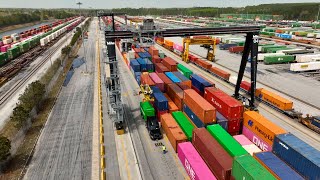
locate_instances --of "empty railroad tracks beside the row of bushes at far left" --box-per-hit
[0,34,67,107]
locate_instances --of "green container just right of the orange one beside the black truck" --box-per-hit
[172,111,194,141]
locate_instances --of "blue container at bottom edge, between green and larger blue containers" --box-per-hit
[255,152,303,180]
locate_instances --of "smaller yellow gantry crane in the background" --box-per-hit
[182,37,216,63]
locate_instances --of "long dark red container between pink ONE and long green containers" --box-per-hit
[192,128,233,180]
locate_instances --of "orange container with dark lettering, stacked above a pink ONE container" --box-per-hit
[243,111,287,145]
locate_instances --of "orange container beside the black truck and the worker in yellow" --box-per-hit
[160,113,187,152]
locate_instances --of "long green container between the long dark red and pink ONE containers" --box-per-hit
[207,124,248,157]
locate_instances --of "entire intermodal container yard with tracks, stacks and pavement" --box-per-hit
[0,5,320,180]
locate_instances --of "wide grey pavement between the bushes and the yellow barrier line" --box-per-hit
[25,19,96,180]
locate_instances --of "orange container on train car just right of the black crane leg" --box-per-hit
[256,88,293,111]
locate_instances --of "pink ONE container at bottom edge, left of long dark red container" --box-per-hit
[178,142,216,180]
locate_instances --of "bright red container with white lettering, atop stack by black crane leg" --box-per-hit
[204,87,243,121]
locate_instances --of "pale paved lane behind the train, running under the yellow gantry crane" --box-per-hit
[165,37,320,115]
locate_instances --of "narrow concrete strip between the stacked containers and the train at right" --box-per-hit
[156,45,320,150]
